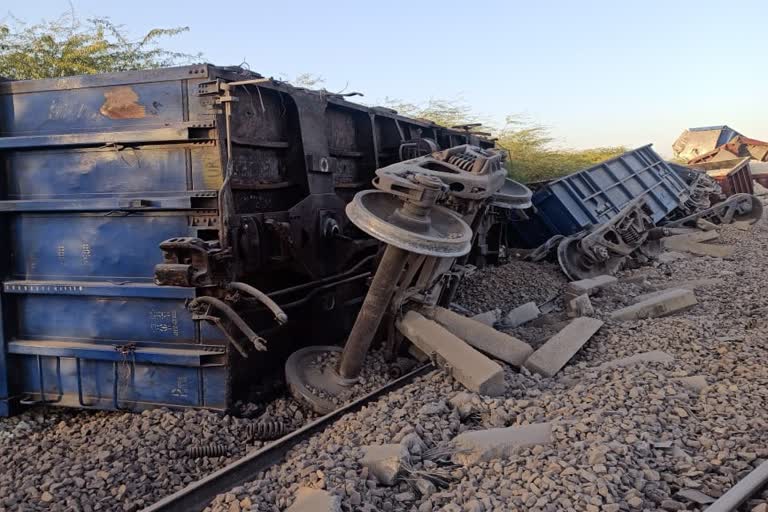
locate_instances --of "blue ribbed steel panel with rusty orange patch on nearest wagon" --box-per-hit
[0,66,229,414]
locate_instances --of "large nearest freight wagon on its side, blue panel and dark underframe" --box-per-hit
[0,65,492,415]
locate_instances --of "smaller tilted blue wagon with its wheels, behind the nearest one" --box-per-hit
[503,145,762,279]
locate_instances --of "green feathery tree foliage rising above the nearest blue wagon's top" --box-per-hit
[0,11,201,80]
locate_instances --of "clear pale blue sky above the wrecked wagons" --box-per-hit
[0,0,768,154]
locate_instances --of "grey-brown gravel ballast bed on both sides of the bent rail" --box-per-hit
[0,202,768,512]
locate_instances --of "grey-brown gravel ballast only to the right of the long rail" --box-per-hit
[201,208,768,512]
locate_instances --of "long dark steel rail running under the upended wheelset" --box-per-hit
[142,364,433,512]
